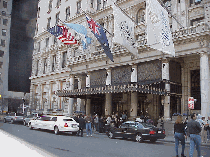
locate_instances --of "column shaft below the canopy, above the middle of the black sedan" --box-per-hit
[130,92,138,118]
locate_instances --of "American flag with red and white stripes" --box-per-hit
[47,25,77,45]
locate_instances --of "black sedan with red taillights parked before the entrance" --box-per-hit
[106,121,166,142]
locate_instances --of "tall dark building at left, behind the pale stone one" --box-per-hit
[8,0,38,93]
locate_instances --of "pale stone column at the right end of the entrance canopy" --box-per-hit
[162,59,170,119]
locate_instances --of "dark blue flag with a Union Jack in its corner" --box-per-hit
[86,15,114,62]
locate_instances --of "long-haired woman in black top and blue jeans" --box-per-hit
[174,115,186,157]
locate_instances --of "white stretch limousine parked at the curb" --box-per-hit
[28,115,79,135]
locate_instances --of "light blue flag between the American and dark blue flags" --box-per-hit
[64,23,92,49]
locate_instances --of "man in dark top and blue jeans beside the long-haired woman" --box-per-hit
[187,113,201,157]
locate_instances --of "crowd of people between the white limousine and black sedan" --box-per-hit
[73,112,127,136]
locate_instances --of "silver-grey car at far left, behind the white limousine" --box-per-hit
[3,112,24,124]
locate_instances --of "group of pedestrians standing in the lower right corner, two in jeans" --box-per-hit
[174,113,210,157]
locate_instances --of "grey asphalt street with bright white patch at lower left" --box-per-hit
[0,118,210,157]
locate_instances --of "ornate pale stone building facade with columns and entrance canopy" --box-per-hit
[30,0,210,119]
